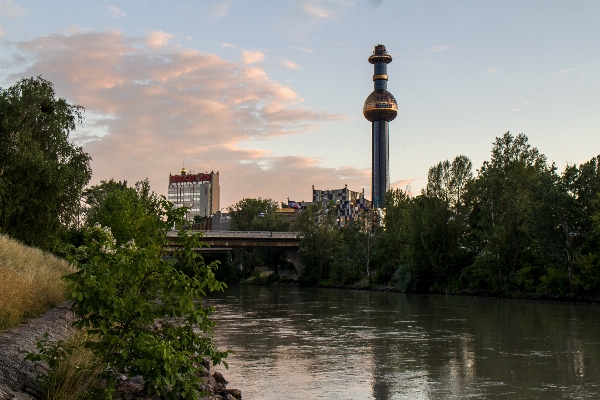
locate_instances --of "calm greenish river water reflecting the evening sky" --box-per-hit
[207,285,600,399]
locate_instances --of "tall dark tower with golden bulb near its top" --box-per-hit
[363,44,398,208]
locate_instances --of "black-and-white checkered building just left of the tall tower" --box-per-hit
[313,185,371,227]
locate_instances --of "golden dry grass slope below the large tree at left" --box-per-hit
[0,235,74,332]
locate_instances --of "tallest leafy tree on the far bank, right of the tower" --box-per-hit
[463,132,555,291]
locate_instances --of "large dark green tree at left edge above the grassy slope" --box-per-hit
[0,77,91,250]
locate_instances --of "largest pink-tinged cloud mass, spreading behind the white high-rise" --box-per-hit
[1,31,354,207]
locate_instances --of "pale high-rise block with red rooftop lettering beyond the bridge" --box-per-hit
[167,168,220,220]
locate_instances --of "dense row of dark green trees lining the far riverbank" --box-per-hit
[296,132,600,297]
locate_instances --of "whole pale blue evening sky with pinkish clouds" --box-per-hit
[0,0,600,208]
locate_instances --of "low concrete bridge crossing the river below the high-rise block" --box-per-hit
[167,231,303,271]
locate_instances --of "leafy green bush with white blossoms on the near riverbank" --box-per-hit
[66,197,229,399]
